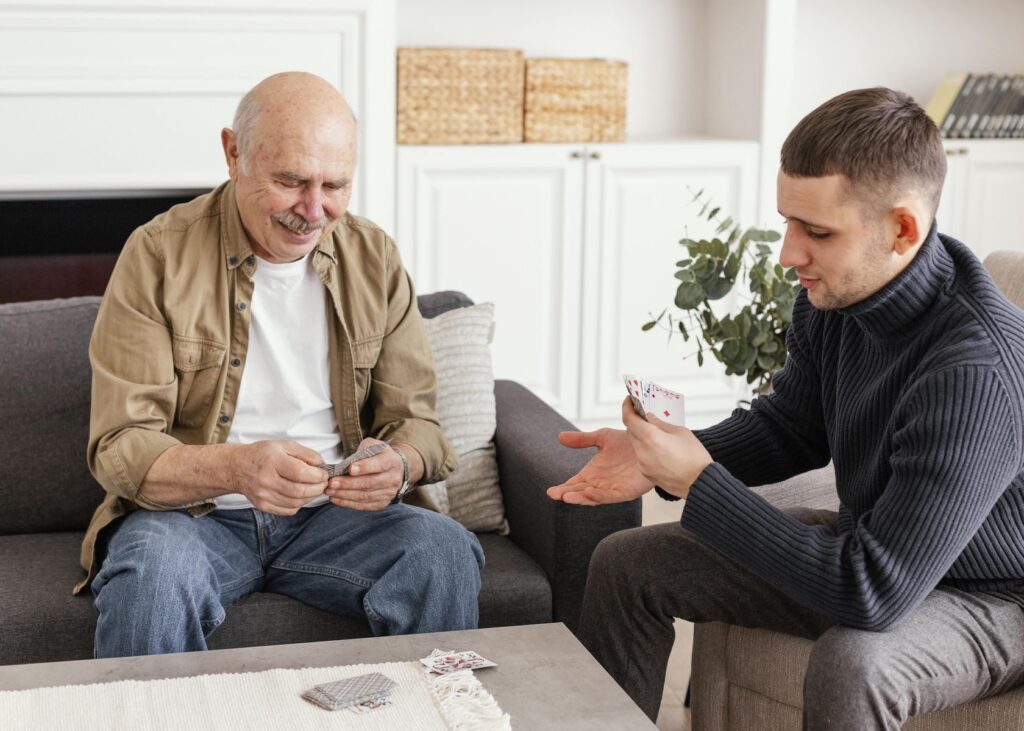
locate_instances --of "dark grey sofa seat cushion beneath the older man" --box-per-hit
[0,531,552,664]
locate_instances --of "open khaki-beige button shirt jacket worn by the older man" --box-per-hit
[75,182,458,593]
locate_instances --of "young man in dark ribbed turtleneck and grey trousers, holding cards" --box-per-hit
[549,88,1024,729]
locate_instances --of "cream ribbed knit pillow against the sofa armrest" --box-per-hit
[419,303,508,533]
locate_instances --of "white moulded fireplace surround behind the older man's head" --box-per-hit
[0,0,394,228]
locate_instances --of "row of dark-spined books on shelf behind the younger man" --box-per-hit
[925,72,1024,139]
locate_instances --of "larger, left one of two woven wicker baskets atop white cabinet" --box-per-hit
[398,48,524,144]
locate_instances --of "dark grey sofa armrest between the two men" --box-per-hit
[495,381,640,632]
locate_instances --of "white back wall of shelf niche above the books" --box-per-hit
[791,0,1024,124]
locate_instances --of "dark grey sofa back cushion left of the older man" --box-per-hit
[0,297,103,536]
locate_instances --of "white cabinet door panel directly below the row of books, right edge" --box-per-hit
[962,140,1024,259]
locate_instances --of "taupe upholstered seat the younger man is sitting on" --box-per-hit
[691,252,1024,731]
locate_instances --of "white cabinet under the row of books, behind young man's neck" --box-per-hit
[936,139,1024,259]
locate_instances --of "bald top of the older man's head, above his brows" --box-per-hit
[231,71,356,175]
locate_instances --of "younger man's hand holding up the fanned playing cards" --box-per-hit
[623,398,714,498]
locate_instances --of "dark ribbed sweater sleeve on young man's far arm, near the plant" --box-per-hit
[694,294,829,485]
